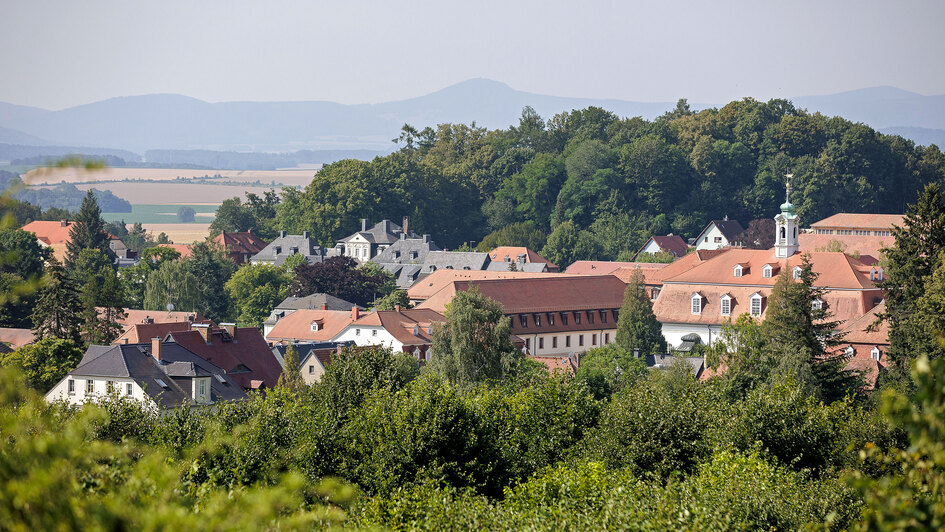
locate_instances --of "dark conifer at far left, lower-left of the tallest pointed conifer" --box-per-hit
[33,258,81,341]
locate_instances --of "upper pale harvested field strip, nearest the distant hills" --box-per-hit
[23,168,315,188]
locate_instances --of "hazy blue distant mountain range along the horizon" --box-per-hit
[0,79,945,156]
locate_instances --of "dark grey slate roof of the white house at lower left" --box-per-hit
[69,342,246,409]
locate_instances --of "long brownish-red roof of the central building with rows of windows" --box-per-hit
[419,275,626,314]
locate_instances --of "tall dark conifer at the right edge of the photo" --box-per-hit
[879,184,945,369]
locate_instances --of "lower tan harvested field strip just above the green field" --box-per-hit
[37,181,280,205]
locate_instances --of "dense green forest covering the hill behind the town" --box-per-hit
[217,99,945,260]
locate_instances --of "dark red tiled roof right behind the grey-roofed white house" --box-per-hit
[168,327,282,390]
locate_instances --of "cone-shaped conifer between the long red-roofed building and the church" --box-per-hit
[616,270,666,355]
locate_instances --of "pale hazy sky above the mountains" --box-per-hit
[0,0,945,109]
